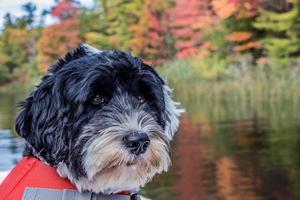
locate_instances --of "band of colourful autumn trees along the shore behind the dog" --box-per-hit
[0,0,300,81]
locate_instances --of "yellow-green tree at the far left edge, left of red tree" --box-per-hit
[0,3,36,78]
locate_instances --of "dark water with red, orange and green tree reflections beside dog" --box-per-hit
[144,115,300,200]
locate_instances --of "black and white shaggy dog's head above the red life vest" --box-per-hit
[16,45,181,193]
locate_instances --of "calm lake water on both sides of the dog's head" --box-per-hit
[0,83,300,200]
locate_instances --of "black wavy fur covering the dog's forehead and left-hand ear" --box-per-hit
[16,47,166,177]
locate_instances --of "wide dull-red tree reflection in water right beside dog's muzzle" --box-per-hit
[173,117,217,200]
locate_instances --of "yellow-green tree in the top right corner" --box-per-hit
[253,0,300,65]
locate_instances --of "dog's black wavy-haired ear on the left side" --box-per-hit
[15,77,68,165]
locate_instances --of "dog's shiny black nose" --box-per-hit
[123,132,150,155]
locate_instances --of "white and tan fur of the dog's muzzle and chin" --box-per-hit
[57,110,171,194]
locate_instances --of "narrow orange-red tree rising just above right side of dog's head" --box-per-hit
[131,0,170,64]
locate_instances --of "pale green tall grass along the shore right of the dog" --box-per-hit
[159,61,300,128]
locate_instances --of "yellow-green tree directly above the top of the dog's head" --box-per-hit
[81,0,144,51]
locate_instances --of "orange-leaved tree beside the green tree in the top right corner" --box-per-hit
[212,0,261,57]
